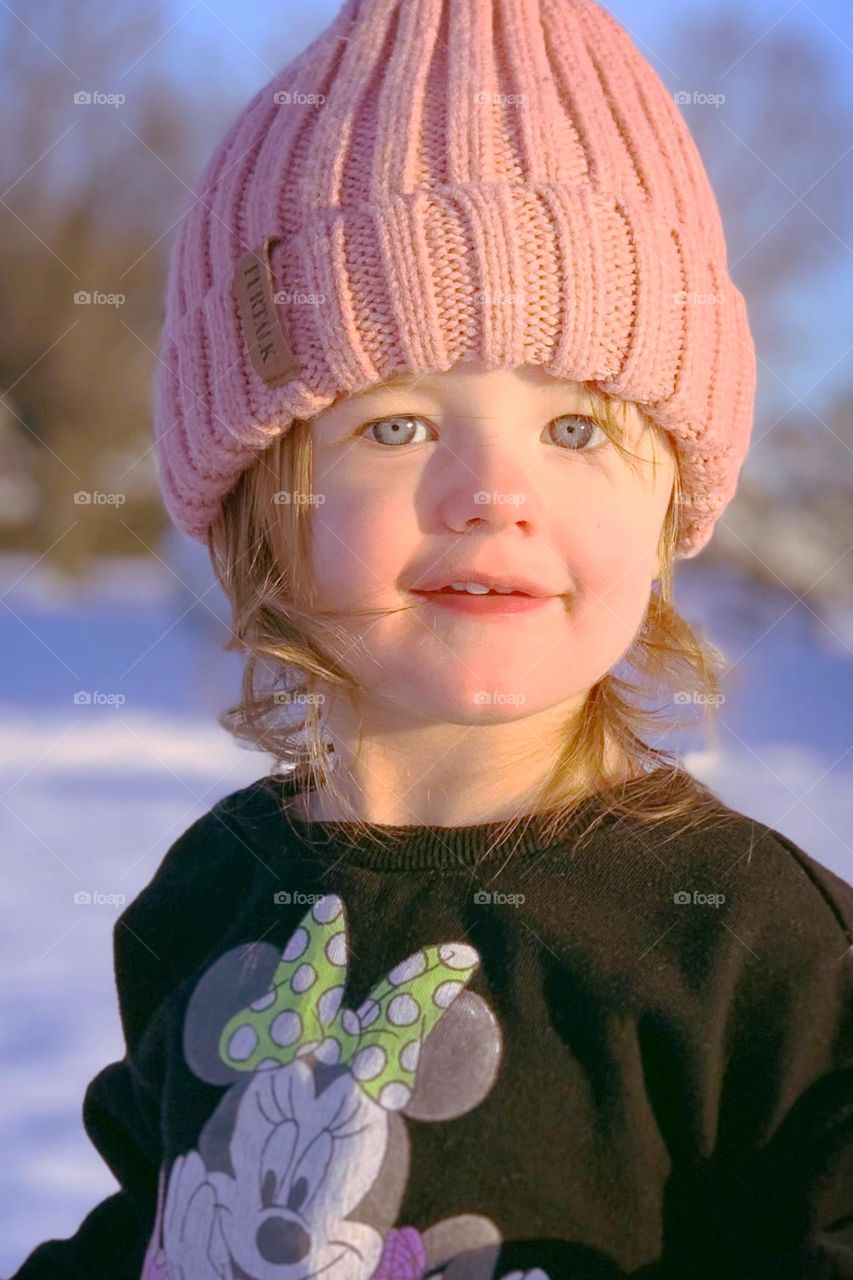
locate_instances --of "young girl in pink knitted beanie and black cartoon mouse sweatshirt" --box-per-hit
[15,0,853,1280]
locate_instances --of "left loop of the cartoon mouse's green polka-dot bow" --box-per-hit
[218,893,350,1071]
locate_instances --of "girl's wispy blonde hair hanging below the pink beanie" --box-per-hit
[207,384,725,846]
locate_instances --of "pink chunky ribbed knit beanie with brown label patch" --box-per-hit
[155,0,756,558]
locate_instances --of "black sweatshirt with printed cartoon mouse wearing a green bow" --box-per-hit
[12,776,853,1280]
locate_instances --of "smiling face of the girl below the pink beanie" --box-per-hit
[298,364,675,727]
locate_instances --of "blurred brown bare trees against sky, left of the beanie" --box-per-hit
[0,0,234,573]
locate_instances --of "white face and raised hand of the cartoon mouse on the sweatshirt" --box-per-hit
[164,1059,388,1280]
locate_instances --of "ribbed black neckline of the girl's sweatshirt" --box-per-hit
[263,765,671,870]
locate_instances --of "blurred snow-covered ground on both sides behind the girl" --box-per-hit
[0,540,853,1276]
